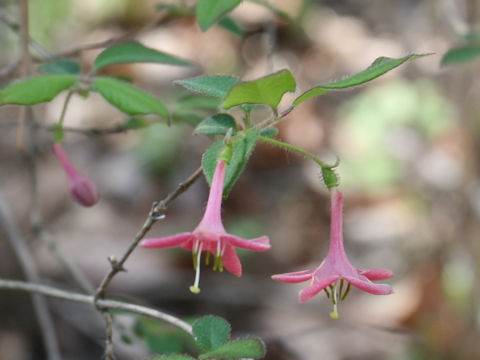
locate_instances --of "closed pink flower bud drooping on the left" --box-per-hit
[53,144,98,207]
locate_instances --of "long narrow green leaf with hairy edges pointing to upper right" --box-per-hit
[293,54,430,106]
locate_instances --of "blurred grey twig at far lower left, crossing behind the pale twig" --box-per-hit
[0,191,61,360]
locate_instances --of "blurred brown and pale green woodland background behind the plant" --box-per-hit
[0,0,480,360]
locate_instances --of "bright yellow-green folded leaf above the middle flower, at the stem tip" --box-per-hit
[222,70,296,109]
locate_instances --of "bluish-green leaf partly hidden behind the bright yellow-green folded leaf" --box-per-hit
[174,75,240,99]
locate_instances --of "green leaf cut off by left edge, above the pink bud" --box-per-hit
[0,75,77,105]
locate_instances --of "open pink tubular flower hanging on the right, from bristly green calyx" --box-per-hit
[272,190,393,319]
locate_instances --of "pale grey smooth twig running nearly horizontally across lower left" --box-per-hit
[0,278,192,334]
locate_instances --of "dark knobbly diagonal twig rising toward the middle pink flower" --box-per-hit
[95,167,202,299]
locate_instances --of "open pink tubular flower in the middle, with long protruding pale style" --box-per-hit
[140,160,270,293]
